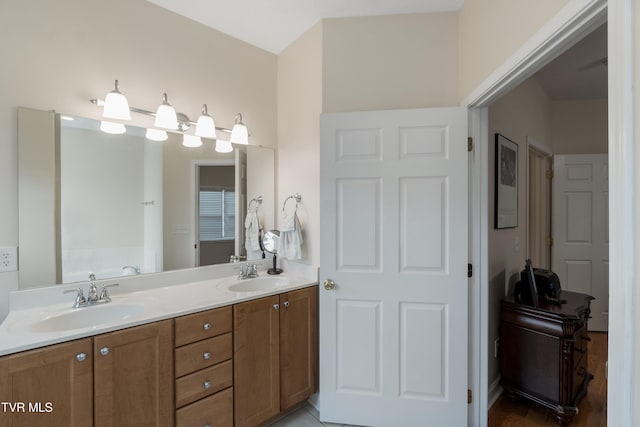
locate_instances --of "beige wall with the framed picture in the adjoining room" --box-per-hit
[487,79,551,384]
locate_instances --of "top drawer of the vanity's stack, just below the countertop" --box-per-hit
[175,306,232,347]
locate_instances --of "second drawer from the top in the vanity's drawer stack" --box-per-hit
[175,333,233,378]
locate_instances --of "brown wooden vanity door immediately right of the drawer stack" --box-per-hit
[233,295,281,427]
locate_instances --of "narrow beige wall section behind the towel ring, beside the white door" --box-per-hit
[276,23,323,266]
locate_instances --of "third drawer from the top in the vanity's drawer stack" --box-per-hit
[176,360,233,408]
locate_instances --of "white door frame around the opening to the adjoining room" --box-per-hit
[461,0,640,426]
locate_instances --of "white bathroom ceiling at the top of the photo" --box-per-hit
[148,0,464,54]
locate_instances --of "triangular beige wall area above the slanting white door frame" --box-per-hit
[458,0,570,99]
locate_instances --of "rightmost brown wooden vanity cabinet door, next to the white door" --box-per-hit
[280,287,318,410]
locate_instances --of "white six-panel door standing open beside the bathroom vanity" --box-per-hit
[320,108,468,427]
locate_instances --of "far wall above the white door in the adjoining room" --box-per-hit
[551,99,608,154]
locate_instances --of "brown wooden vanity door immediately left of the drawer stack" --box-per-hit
[94,320,174,427]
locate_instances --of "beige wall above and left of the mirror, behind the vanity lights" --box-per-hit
[0,0,276,318]
